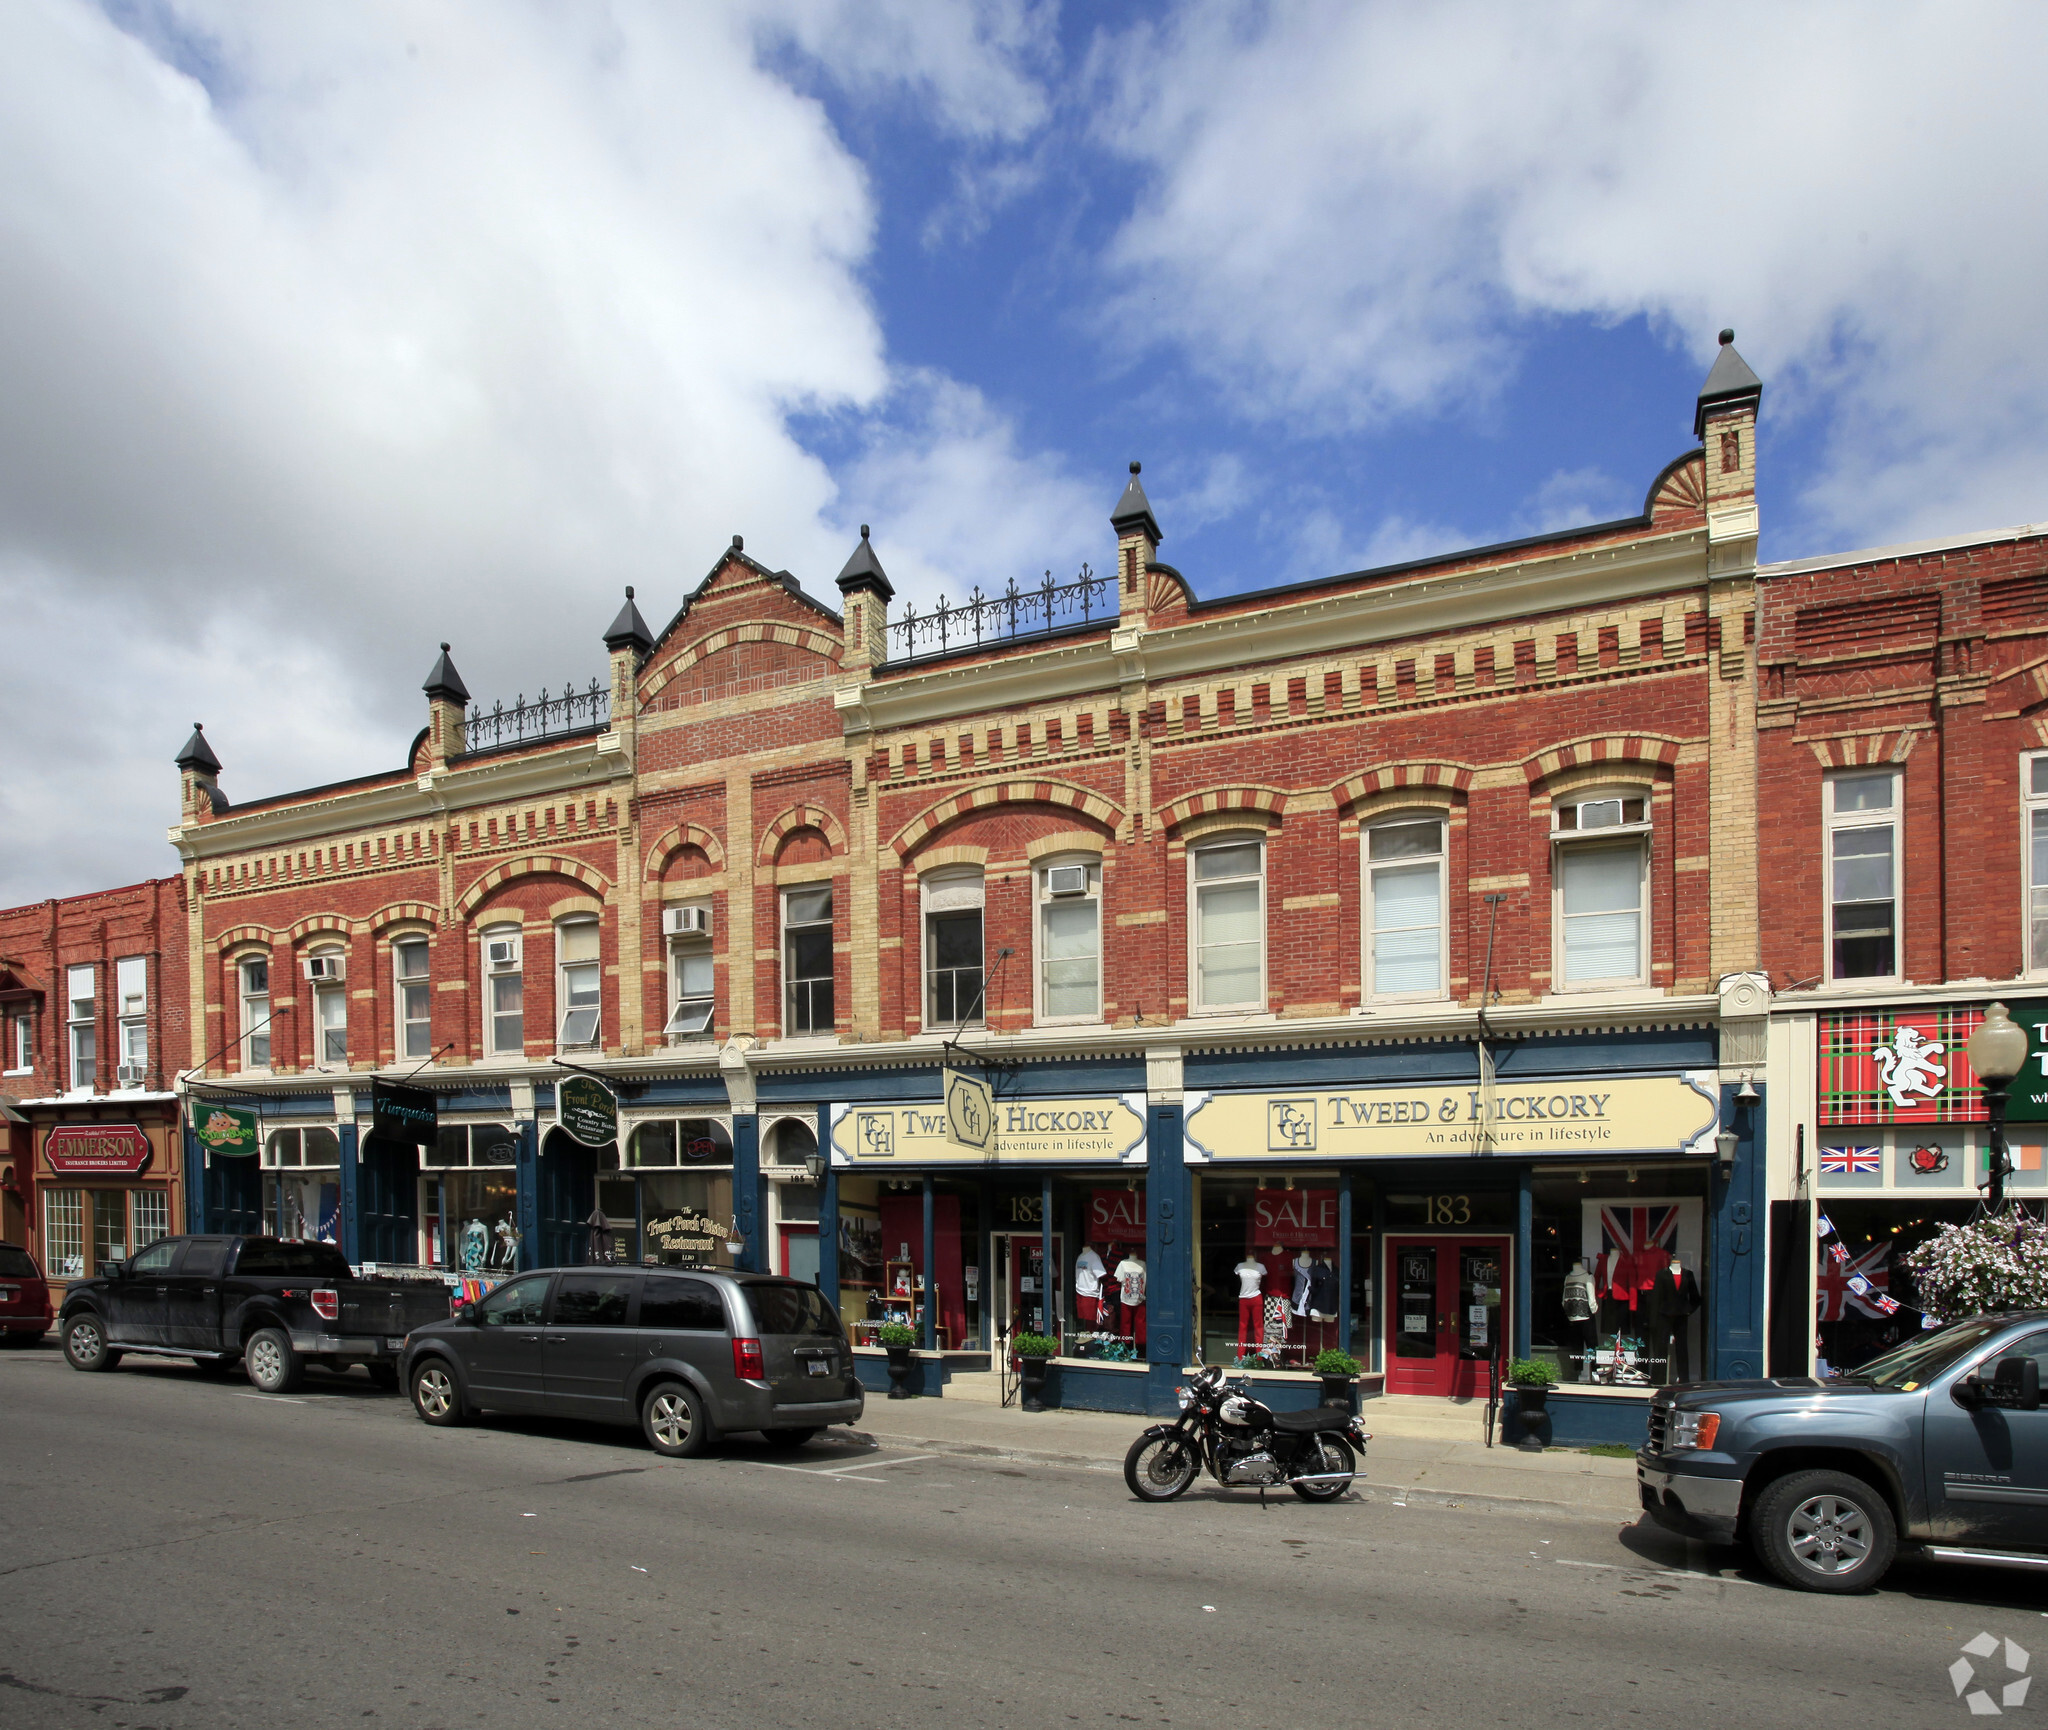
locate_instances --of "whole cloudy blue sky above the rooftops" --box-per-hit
[0,0,2048,903]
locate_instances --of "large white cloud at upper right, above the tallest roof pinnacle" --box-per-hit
[1098,4,2048,545]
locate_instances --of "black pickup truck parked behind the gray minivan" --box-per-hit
[57,1237,449,1394]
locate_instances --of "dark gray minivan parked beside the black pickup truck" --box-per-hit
[403,1265,866,1458]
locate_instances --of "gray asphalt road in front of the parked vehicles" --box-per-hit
[0,1349,2048,1730]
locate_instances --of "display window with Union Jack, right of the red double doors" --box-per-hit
[1530,1165,1706,1388]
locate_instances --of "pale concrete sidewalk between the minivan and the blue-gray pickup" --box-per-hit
[858,1396,1640,1519]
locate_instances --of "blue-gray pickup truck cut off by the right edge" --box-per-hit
[1636,1310,2048,1593]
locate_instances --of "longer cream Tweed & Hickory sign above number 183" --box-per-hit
[1186,1069,1720,1163]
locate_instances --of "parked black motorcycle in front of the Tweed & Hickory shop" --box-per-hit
[1124,1364,1372,1503]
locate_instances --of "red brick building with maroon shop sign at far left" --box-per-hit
[0,878,193,1282]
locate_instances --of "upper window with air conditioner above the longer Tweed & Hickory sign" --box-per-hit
[1550,788,1651,991]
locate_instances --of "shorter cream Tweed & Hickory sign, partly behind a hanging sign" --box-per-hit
[831,1093,1145,1167]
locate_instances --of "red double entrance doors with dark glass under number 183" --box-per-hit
[1382,1237,1511,1398]
